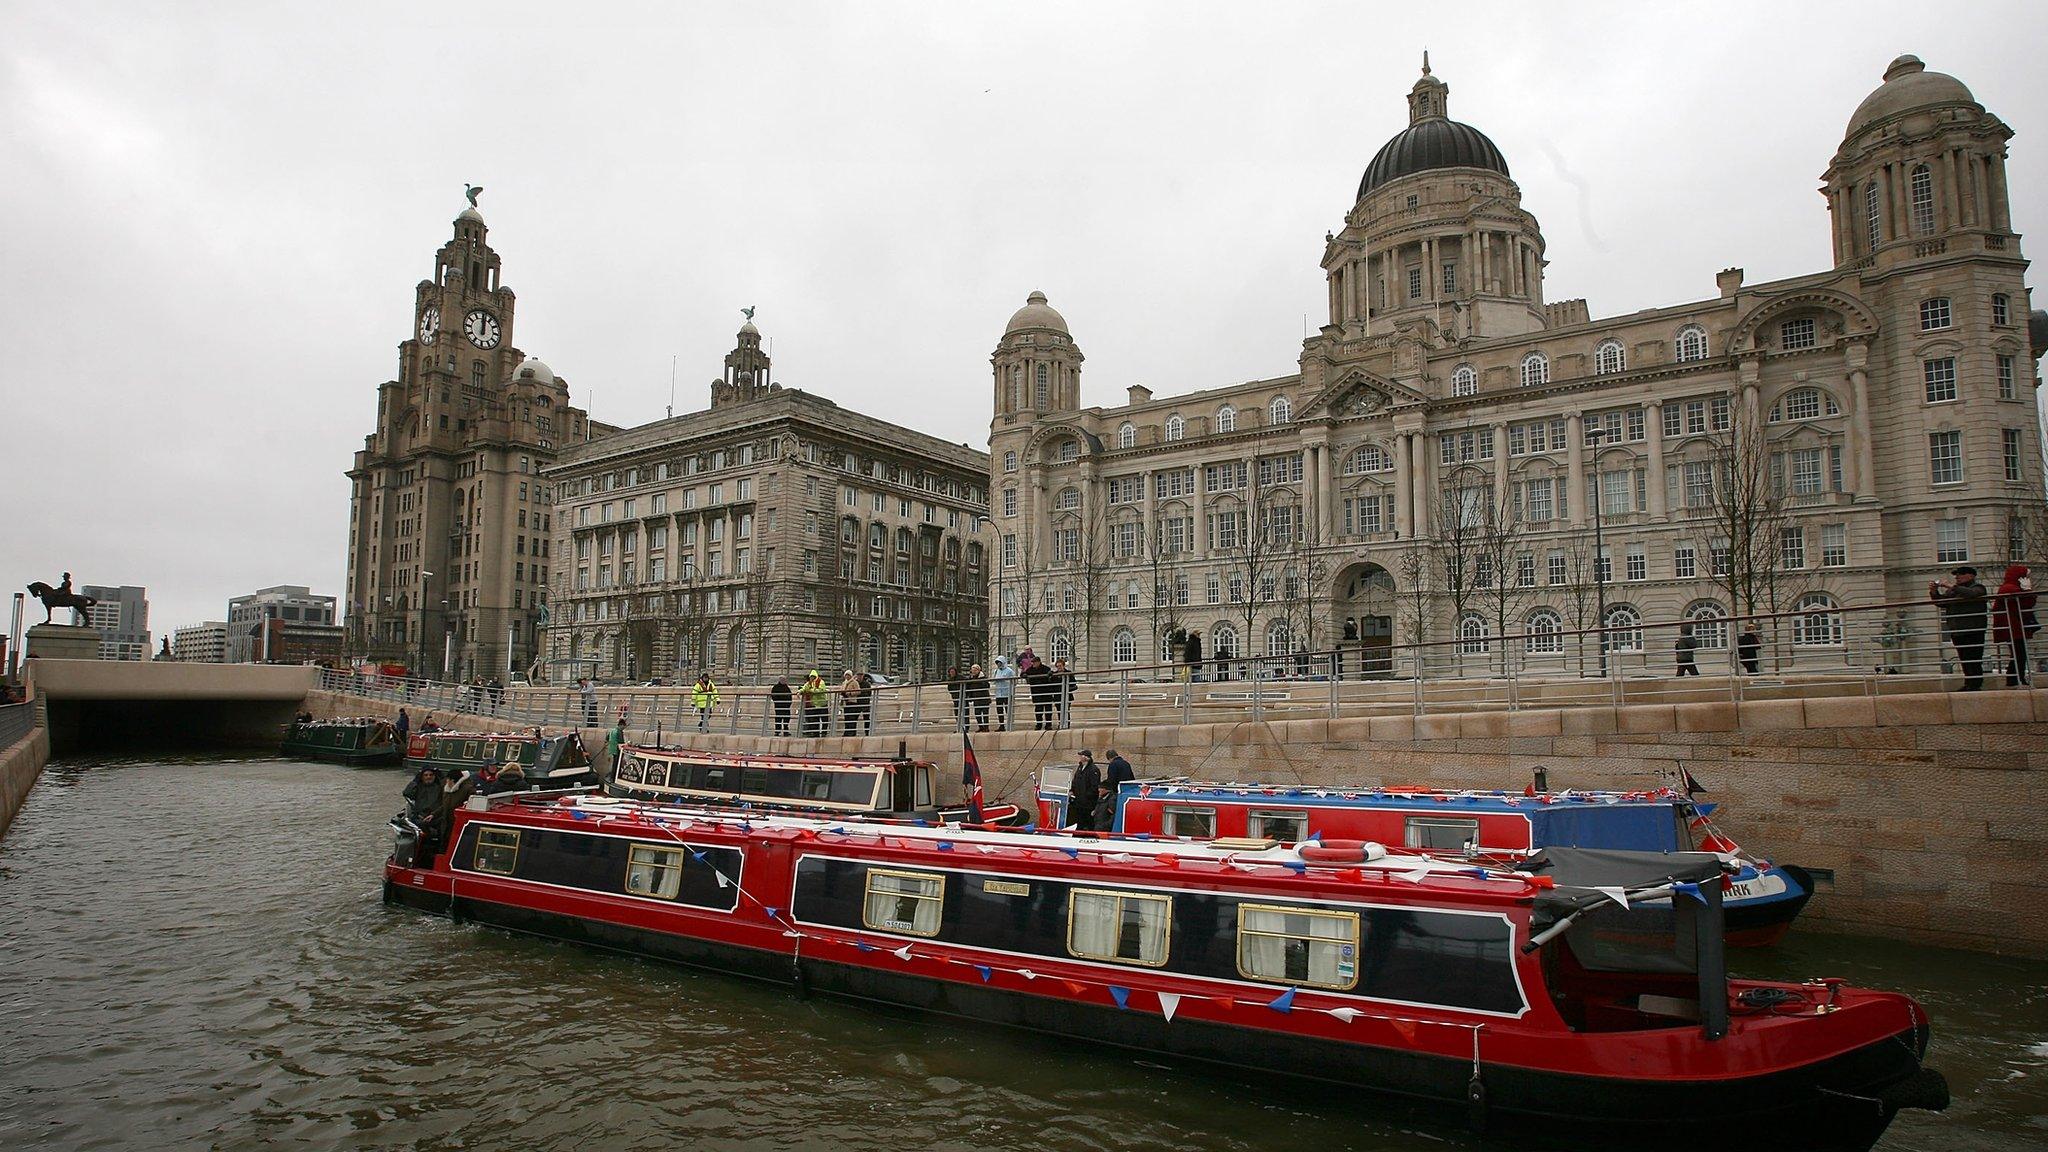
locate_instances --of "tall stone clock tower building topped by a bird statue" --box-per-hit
[346,207,608,676]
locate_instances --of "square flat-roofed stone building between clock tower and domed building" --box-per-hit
[545,320,989,685]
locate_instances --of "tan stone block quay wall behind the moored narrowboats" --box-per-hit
[309,689,2048,955]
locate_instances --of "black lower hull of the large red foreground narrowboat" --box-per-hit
[385,865,1948,1152]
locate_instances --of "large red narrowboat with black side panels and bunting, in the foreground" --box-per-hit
[385,795,1948,1152]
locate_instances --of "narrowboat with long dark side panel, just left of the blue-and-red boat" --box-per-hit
[606,744,1026,824]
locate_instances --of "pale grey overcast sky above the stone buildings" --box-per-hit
[0,0,2048,633]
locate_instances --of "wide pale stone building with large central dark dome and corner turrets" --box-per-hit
[989,57,2048,674]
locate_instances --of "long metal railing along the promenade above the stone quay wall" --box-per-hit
[322,596,2032,740]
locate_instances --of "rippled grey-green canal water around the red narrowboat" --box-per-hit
[0,758,2048,1152]
